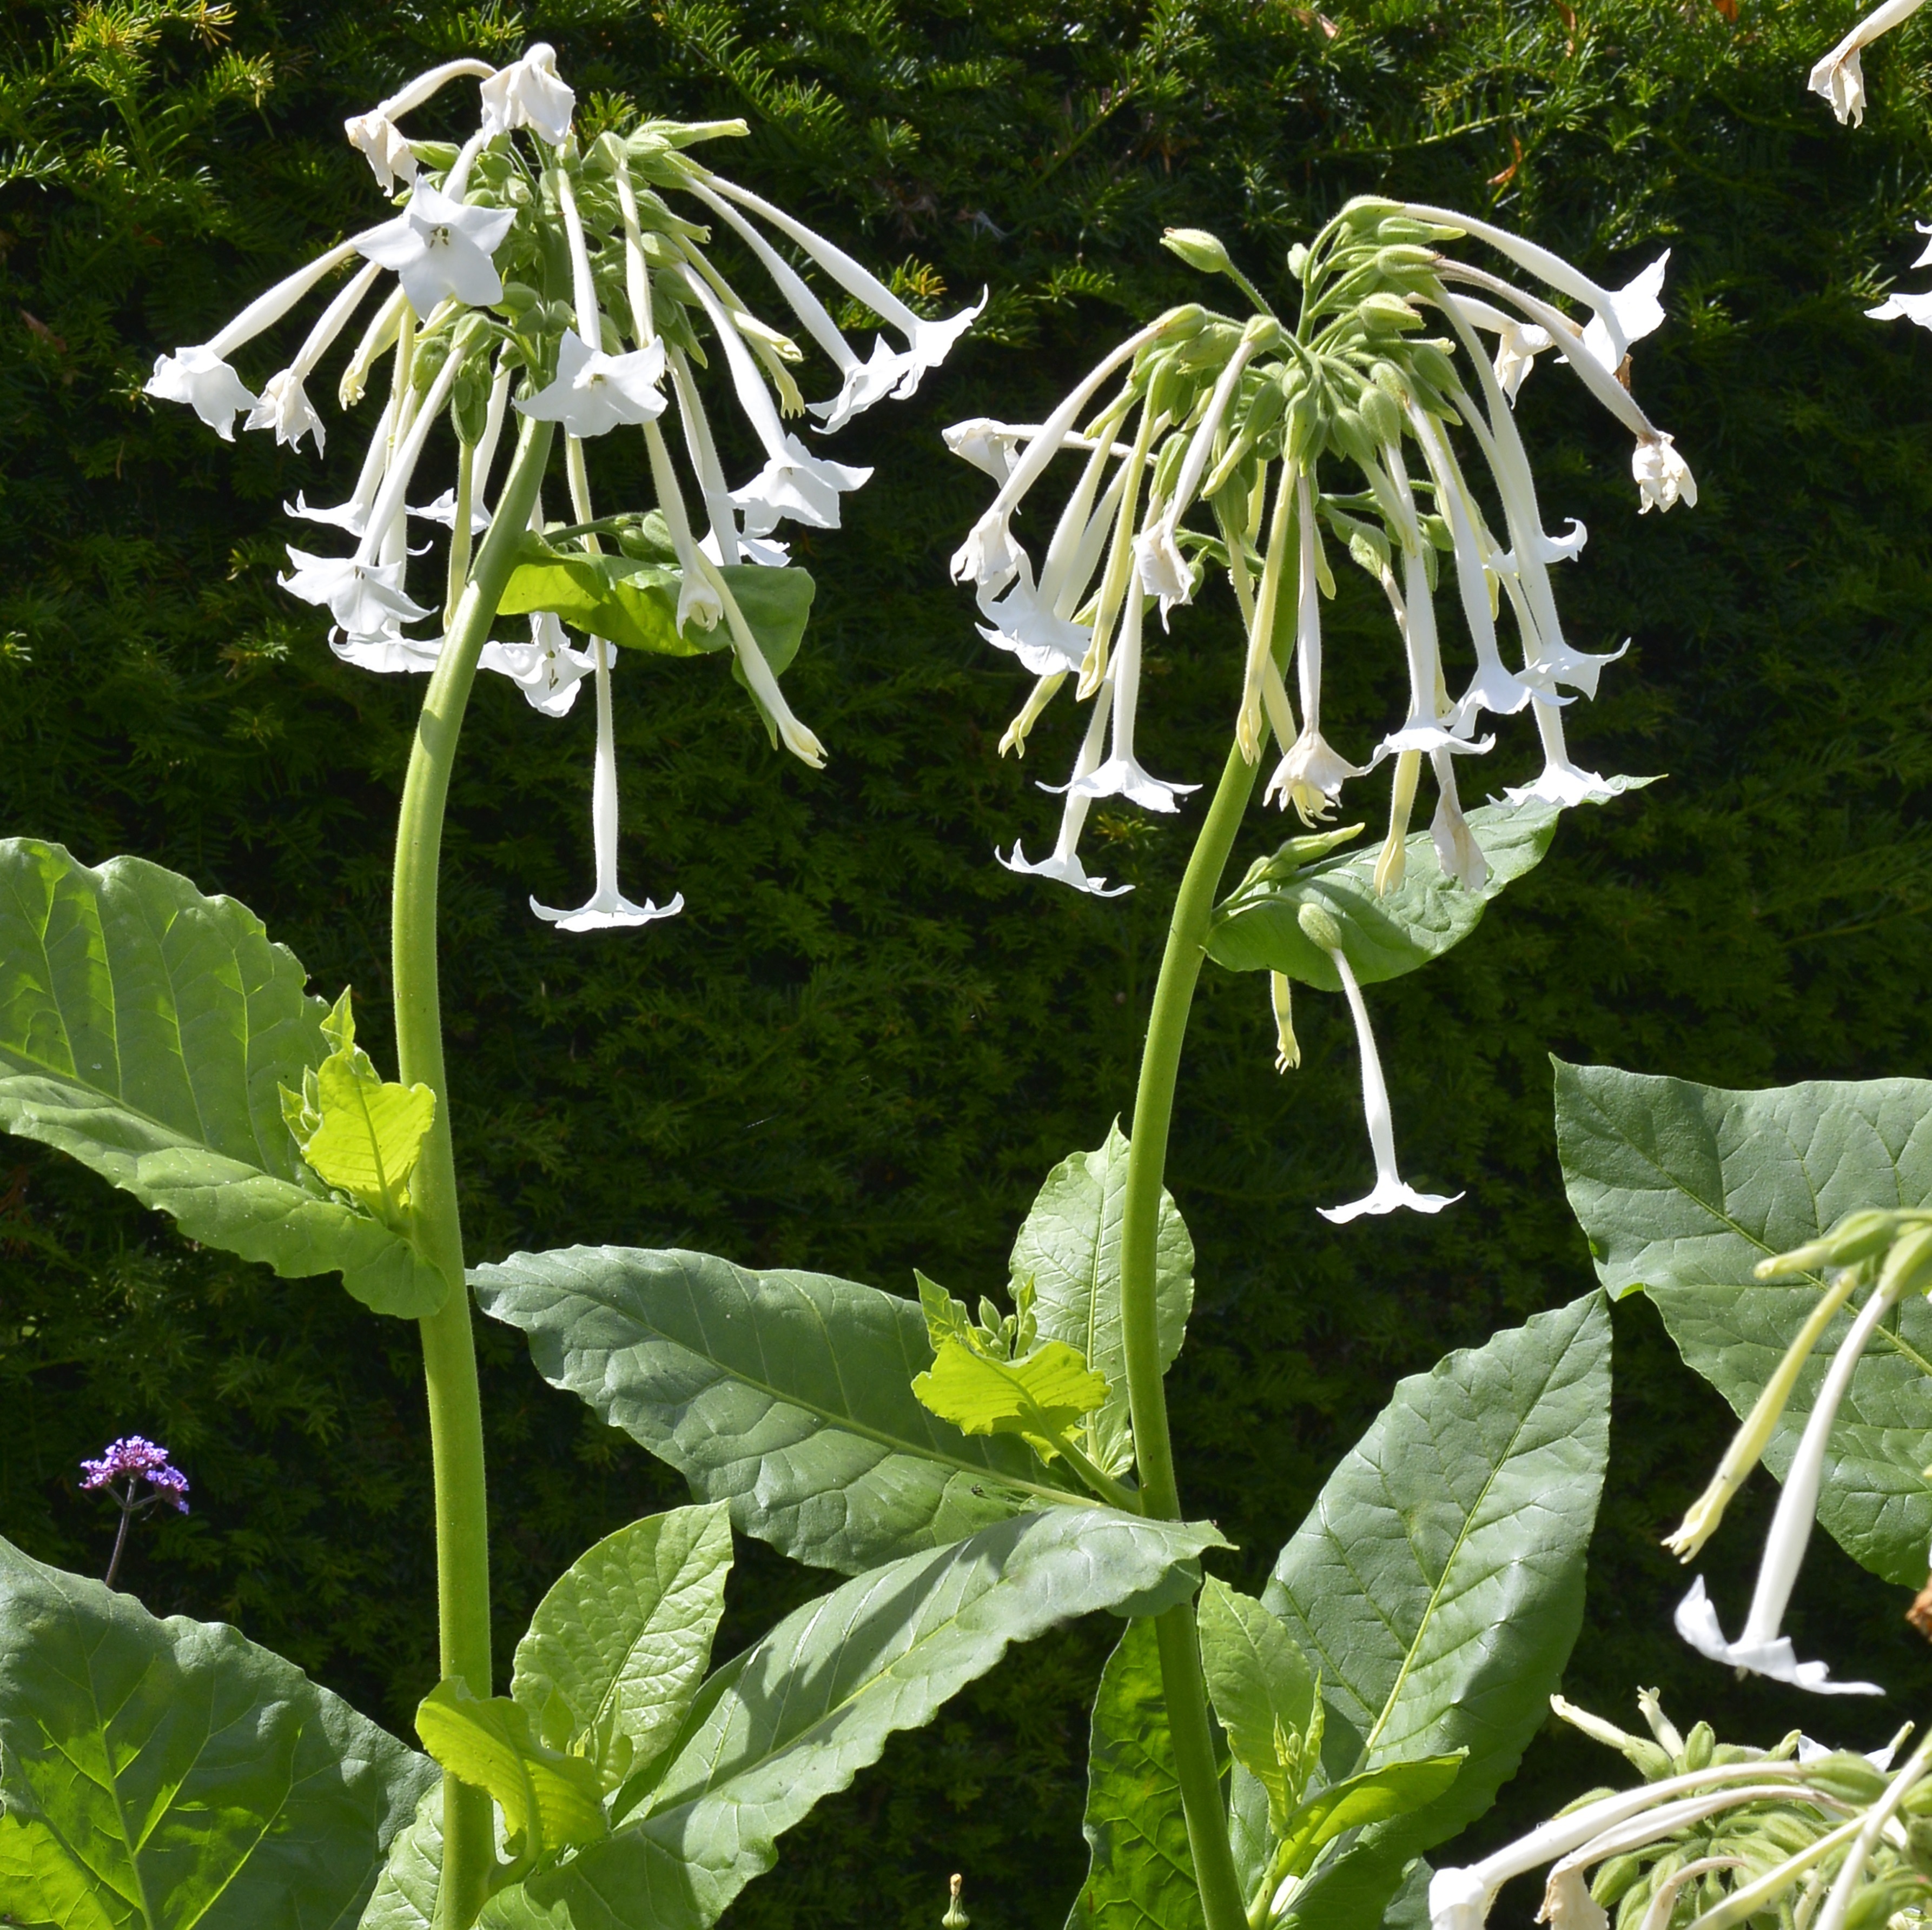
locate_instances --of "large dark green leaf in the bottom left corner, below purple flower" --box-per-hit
[0,1542,436,1930]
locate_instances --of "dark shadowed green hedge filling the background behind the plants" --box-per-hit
[0,0,1932,1930]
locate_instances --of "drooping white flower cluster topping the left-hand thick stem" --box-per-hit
[147,44,977,931]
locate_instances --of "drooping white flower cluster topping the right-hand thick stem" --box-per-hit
[947,199,1696,894]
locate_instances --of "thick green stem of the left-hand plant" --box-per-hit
[391,421,553,1930]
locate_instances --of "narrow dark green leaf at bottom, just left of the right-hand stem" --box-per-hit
[1067,1621,1206,1930]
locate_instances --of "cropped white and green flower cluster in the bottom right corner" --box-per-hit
[1430,1690,1932,1930]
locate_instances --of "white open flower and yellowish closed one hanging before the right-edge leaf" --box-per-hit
[1663,1209,1932,1696]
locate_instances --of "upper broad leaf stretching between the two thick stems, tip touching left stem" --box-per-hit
[472,1246,1067,1575]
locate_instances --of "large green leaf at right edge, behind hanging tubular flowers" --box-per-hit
[1557,1060,1932,1586]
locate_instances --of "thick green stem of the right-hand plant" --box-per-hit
[1121,744,1262,1930]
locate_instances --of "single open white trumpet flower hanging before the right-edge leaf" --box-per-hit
[1677,1268,1905,1696]
